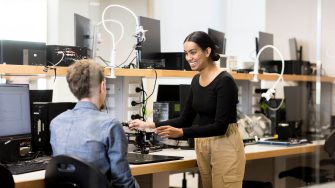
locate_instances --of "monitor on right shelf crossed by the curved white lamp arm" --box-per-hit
[257,32,273,62]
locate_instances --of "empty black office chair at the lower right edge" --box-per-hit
[279,131,335,185]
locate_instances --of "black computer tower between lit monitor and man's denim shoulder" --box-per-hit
[31,102,76,155]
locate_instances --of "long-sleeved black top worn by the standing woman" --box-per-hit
[156,71,238,138]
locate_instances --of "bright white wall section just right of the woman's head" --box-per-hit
[225,0,266,64]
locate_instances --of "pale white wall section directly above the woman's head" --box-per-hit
[153,0,225,52]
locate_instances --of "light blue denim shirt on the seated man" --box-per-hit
[50,102,139,188]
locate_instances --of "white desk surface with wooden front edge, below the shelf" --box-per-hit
[13,141,324,188]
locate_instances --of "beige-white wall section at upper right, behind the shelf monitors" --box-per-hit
[266,0,317,63]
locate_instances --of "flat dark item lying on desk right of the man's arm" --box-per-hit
[127,153,184,164]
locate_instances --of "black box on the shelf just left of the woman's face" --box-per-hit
[161,52,191,70]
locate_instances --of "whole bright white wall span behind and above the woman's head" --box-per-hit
[153,0,265,67]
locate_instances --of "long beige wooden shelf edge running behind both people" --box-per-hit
[0,65,335,83]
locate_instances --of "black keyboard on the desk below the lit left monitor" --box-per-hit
[3,157,50,175]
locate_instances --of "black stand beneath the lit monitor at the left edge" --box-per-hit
[0,140,20,163]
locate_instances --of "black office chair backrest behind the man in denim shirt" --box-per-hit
[44,155,111,188]
